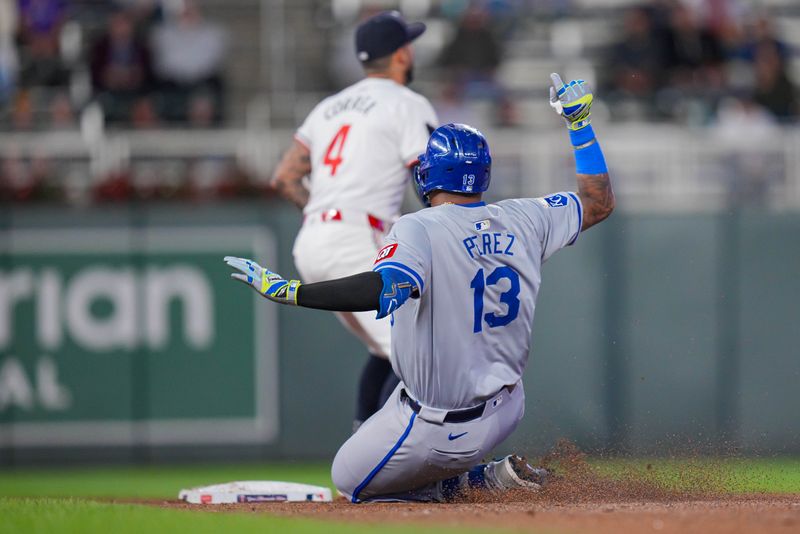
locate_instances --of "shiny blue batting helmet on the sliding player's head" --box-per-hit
[414,124,492,206]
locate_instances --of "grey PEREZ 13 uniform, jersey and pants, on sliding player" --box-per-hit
[332,192,582,502]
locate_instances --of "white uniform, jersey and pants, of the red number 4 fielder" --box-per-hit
[293,78,438,358]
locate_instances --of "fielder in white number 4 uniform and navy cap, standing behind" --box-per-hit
[273,11,438,429]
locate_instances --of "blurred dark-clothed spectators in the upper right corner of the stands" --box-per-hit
[601,0,800,124]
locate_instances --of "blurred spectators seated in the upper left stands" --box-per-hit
[0,0,228,131]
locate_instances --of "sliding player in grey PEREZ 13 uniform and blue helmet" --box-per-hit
[225,74,614,503]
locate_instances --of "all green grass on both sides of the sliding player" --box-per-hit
[0,458,800,534]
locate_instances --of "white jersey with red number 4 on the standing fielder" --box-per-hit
[296,78,438,223]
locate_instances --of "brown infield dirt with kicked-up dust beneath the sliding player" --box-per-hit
[138,442,800,534]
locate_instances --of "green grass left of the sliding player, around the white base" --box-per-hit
[0,463,512,534]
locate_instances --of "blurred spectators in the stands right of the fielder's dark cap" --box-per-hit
[437,0,800,127]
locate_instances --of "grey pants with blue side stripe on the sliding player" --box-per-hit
[332,384,524,502]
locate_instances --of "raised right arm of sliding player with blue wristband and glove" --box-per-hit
[550,73,615,230]
